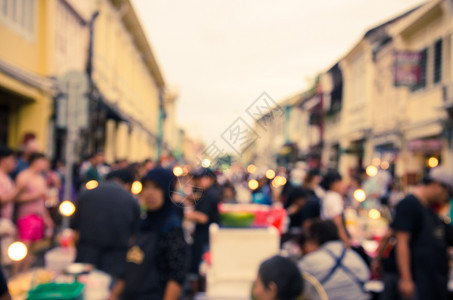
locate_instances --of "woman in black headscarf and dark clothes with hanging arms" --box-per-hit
[110,168,187,300]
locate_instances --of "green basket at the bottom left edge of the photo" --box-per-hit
[27,282,84,300]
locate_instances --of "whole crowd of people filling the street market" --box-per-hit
[0,140,453,300]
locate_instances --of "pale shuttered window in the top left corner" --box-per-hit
[0,0,37,39]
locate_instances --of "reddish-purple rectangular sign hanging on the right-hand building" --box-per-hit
[394,51,421,87]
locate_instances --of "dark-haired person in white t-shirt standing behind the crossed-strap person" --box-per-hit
[321,171,351,248]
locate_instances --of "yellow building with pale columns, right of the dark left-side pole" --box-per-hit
[92,0,166,162]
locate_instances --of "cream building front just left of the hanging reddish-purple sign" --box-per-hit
[330,8,419,177]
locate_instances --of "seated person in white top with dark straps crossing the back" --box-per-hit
[298,220,370,300]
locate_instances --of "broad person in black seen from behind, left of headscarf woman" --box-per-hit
[71,169,140,280]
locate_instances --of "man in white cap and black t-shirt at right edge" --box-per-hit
[391,167,453,300]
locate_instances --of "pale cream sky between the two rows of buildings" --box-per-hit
[132,0,423,144]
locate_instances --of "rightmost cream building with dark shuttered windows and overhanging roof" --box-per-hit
[392,0,453,183]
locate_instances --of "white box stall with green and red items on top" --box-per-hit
[196,204,286,300]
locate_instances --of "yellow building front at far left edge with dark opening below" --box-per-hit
[0,0,55,150]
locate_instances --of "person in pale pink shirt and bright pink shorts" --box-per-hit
[16,153,54,272]
